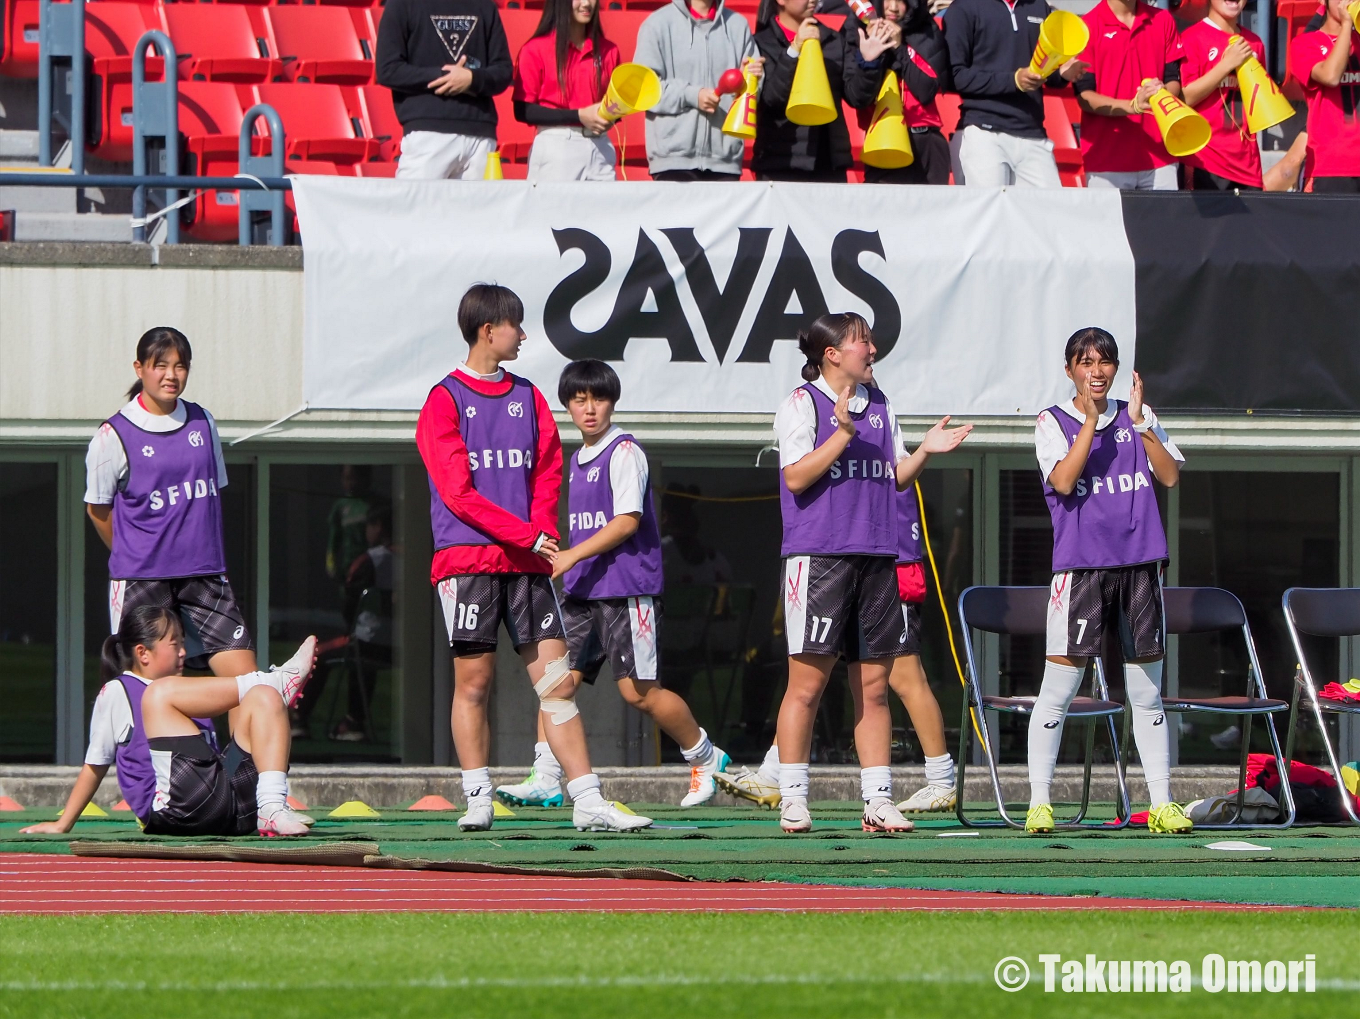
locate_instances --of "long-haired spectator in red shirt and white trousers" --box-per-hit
[514,0,619,181]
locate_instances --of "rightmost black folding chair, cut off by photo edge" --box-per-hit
[1280,588,1360,824]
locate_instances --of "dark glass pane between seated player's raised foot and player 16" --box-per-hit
[268,464,403,762]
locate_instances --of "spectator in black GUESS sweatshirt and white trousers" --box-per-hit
[375,0,514,181]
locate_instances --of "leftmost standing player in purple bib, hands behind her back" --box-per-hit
[86,327,256,676]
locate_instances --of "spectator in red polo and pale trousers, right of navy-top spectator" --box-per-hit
[1076,0,1185,190]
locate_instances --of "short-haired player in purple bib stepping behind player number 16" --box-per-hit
[496,359,729,807]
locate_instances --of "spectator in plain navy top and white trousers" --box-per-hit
[941,0,1085,188]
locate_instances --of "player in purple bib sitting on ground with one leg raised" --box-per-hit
[23,605,317,835]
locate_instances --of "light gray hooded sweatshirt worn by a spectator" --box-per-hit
[632,0,758,174]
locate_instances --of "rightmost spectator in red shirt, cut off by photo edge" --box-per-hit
[1289,0,1360,193]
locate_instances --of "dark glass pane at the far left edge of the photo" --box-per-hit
[0,464,58,763]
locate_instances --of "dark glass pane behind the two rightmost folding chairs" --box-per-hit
[1178,471,1341,763]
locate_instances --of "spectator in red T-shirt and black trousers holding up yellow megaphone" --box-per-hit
[1180,0,1266,190]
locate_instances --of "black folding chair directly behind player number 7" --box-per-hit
[955,588,1132,829]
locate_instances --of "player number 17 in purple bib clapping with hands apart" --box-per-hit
[775,313,971,833]
